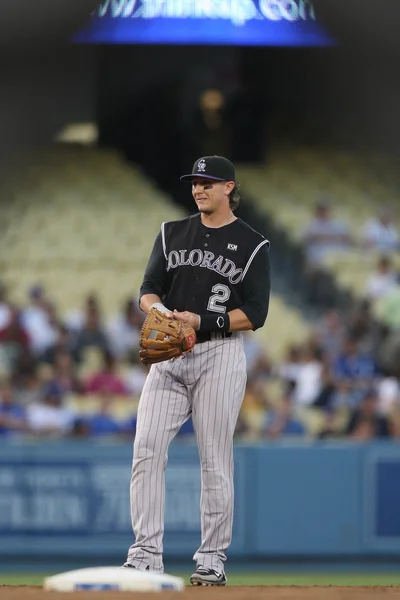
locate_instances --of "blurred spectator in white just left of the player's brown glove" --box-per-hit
[107,299,144,358]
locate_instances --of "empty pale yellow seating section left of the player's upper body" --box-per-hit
[0,146,183,315]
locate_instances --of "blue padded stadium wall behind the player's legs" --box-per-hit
[0,441,400,569]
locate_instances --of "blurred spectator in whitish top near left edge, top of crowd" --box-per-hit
[21,285,57,355]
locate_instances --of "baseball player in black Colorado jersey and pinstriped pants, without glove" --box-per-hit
[123,156,270,585]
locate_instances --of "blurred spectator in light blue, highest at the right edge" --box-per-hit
[363,206,400,252]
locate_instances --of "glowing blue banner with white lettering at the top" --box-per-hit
[73,0,335,46]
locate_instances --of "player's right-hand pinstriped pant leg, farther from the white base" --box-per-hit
[193,338,246,571]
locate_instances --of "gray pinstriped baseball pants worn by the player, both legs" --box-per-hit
[127,333,246,572]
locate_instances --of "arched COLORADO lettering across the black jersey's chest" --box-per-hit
[167,248,243,285]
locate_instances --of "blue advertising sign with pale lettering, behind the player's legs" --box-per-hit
[0,461,200,537]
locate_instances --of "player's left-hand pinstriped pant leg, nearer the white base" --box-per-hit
[128,361,190,571]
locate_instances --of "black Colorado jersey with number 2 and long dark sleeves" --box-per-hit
[140,213,270,329]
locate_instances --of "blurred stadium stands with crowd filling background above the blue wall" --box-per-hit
[0,0,400,441]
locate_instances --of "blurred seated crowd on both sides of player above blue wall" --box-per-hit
[0,190,400,440]
